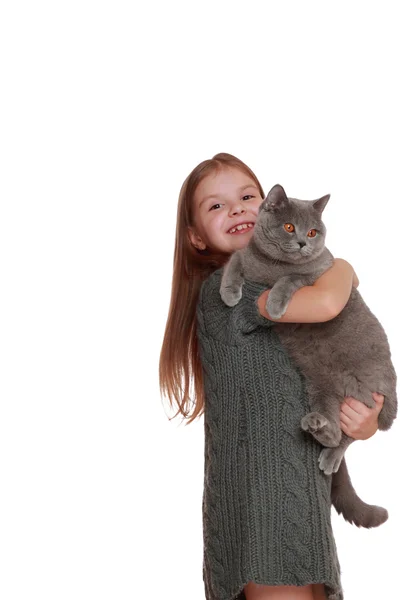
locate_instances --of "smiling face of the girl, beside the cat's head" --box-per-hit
[189,168,263,253]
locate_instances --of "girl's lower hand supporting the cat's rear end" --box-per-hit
[340,392,385,440]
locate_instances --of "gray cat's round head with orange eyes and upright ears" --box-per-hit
[252,184,330,264]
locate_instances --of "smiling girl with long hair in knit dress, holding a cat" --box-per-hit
[160,154,383,600]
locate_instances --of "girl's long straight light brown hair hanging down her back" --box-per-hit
[159,153,264,425]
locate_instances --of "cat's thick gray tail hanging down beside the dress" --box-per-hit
[331,457,389,529]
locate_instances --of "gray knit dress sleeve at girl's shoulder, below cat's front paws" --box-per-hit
[197,268,275,344]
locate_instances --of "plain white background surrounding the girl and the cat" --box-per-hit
[0,0,400,600]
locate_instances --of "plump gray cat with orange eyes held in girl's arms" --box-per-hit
[220,185,397,527]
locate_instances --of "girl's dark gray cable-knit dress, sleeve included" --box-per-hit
[197,269,343,600]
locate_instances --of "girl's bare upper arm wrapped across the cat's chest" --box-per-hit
[257,258,359,323]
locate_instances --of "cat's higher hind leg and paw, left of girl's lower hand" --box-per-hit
[301,381,342,448]
